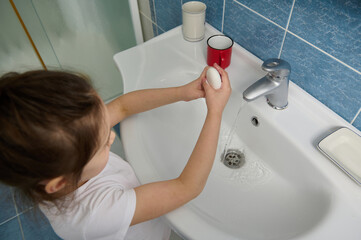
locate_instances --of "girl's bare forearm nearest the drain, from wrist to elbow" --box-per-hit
[178,112,222,198]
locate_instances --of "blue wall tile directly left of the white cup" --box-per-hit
[154,0,182,31]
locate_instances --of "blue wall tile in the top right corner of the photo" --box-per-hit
[289,0,361,71]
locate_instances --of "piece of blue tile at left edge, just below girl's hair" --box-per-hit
[0,184,16,224]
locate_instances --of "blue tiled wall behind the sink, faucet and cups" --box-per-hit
[150,0,361,130]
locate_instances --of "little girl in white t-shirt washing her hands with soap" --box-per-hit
[0,65,231,240]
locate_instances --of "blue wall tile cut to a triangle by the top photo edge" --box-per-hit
[238,0,293,28]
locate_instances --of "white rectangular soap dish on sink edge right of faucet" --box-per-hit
[318,128,361,185]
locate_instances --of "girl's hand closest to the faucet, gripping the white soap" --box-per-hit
[202,63,232,114]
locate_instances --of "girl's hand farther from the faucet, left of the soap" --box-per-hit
[181,66,209,102]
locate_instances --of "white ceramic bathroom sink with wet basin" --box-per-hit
[114,24,361,240]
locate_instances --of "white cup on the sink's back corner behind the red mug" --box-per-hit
[182,1,207,42]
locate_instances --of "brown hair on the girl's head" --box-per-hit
[0,70,103,206]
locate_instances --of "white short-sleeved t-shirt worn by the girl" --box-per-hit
[39,152,170,240]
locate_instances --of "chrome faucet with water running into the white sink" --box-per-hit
[243,58,291,110]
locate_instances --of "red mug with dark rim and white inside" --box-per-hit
[207,35,233,69]
